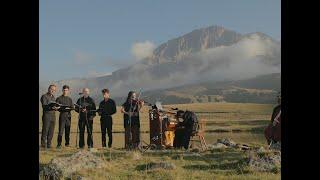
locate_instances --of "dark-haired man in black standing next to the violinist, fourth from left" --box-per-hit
[98,89,117,148]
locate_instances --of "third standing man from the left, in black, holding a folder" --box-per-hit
[75,88,96,148]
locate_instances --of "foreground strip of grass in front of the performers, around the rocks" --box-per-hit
[40,148,280,179]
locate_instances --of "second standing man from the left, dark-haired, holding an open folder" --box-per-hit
[56,85,73,148]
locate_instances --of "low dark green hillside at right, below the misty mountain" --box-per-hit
[116,73,281,104]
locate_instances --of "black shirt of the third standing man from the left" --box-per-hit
[75,96,96,120]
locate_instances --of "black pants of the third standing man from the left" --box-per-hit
[79,118,93,148]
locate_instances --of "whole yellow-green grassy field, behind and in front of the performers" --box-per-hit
[39,103,280,179]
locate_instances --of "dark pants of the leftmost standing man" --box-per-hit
[41,112,56,147]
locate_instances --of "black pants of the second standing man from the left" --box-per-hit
[58,112,71,146]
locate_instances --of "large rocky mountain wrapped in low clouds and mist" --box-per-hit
[39,26,281,104]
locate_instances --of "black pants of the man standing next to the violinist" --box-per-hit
[100,116,112,147]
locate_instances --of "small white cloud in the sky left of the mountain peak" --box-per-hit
[131,40,156,60]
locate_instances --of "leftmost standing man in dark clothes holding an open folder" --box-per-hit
[40,84,59,148]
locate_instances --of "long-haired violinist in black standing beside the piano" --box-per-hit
[121,91,144,149]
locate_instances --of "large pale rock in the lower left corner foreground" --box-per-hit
[40,150,106,179]
